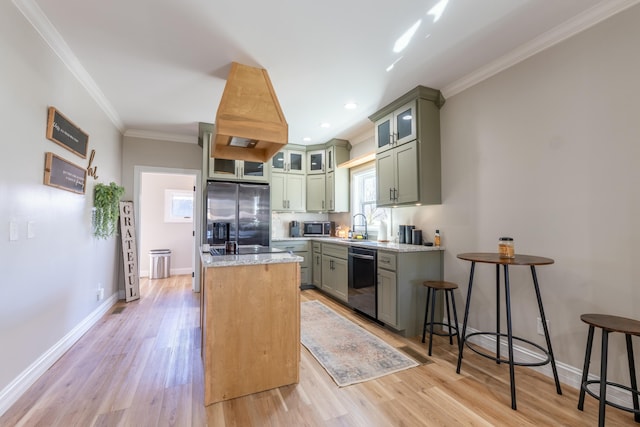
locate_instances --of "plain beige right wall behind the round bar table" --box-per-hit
[394,6,640,381]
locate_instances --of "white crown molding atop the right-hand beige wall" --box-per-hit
[442,0,640,98]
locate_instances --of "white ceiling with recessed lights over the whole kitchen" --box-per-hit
[14,0,638,144]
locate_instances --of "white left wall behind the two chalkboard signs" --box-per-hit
[0,2,122,413]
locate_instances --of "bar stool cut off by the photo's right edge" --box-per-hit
[578,314,640,426]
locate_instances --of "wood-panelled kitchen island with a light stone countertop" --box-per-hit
[200,252,302,405]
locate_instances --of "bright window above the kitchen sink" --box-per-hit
[351,164,387,231]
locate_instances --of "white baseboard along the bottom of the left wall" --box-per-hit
[0,294,118,416]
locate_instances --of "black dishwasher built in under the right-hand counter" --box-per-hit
[348,246,378,320]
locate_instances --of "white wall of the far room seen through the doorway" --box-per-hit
[139,173,196,276]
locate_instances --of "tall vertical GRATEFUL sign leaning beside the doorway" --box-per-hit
[120,201,140,302]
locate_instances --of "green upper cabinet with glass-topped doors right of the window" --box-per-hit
[369,86,444,206]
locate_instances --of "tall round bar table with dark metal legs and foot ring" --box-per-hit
[456,252,562,410]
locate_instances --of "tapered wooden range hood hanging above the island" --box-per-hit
[211,62,289,162]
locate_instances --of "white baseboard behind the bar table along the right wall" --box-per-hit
[459,325,633,407]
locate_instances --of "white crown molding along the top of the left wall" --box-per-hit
[13,0,124,133]
